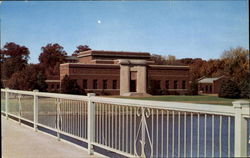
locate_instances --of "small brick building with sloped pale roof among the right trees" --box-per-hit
[198,76,228,94]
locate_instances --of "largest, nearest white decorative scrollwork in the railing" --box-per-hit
[134,107,153,158]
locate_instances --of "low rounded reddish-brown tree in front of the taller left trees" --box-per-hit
[7,64,47,91]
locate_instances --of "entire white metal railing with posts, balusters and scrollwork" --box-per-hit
[1,89,250,157]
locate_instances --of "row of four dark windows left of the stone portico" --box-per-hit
[82,79,117,89]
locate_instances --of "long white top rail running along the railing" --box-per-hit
[1,89,250,116]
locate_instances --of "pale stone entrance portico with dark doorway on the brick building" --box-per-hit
[119,59,147,96]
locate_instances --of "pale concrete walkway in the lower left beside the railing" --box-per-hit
[1,116,100,158]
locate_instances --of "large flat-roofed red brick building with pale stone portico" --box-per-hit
[56,50,189,95]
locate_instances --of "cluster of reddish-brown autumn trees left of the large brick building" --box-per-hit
[0,42,91,91]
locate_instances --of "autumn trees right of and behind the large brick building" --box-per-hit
[153,47,250,98]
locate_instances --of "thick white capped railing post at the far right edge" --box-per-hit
[233,100,250,157]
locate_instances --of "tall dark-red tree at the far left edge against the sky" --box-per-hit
[0,42,30,80]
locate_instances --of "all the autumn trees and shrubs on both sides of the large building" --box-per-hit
[0,42,250,98]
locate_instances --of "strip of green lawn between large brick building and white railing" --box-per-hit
[114,95,250,105]
